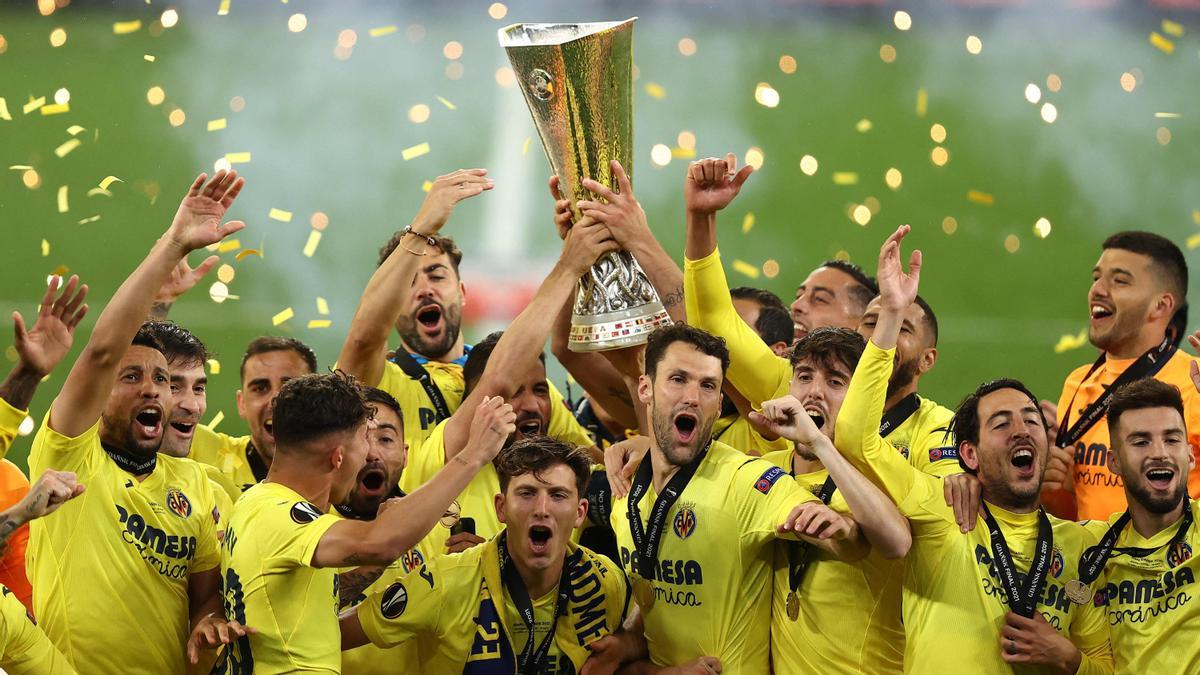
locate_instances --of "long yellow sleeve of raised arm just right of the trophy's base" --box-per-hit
[683,250,792,406]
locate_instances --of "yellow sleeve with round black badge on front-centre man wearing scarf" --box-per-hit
[358,558,451,647]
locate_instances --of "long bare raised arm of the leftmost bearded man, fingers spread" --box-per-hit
[49,171,246,437]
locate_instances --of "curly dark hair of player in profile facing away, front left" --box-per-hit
[271,371,371,446]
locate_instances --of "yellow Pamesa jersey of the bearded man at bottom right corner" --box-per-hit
[1084,501,1200,675]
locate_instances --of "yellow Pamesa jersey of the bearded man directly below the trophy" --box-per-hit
[610,441,816,675]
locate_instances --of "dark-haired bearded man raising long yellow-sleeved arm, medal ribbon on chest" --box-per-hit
[834,226,1112,674]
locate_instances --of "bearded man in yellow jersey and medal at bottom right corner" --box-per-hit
[1072,374,1200,675]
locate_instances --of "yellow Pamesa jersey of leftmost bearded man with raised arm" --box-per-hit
[26,414,218,674]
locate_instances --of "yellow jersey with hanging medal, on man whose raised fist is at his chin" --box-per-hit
[762,450,904,675]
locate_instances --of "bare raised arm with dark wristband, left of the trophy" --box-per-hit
[337,169,493,387]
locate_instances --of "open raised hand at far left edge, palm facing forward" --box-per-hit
[12,276,88,378]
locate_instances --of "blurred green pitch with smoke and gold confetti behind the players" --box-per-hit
[0,0,1200,466]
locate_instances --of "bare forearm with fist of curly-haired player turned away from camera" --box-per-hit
[312,398,516,567]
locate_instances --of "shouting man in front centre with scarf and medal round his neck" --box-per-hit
[341,436,646,675]
